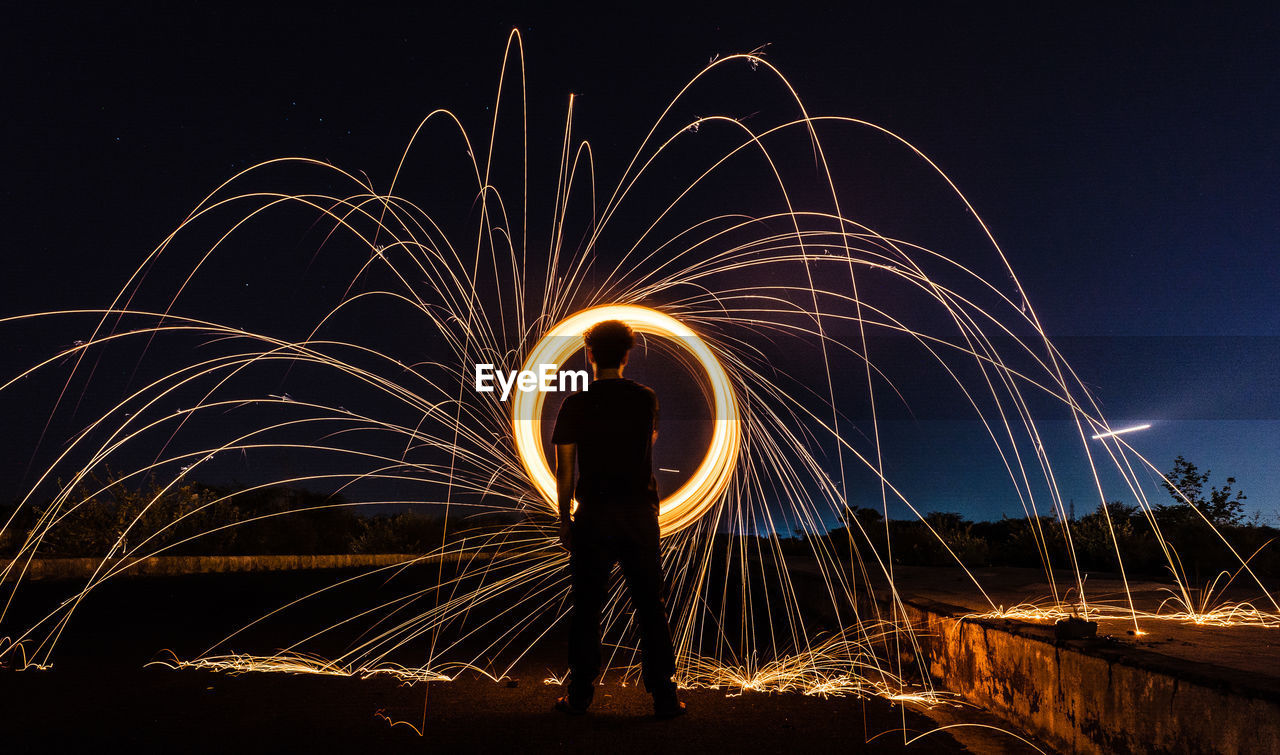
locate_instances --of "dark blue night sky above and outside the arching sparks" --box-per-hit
[0,3,1280,523]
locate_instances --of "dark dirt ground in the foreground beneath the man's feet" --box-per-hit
[0,573,1033,752]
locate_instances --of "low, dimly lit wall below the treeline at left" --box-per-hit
[0,553,439,582]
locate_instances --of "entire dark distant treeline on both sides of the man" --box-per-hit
[0,457,1280,581]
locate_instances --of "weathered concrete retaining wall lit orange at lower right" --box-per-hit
[906,600,1280,752]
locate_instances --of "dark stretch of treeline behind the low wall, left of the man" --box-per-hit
[0,480,509,557]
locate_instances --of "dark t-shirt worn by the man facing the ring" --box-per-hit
[552,378,658,517]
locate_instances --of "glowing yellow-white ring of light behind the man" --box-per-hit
[512,305,741,536]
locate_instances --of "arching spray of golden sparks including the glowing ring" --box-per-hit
[0,33,1280,731]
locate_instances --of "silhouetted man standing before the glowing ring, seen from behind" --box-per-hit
[552,320,685,718]
